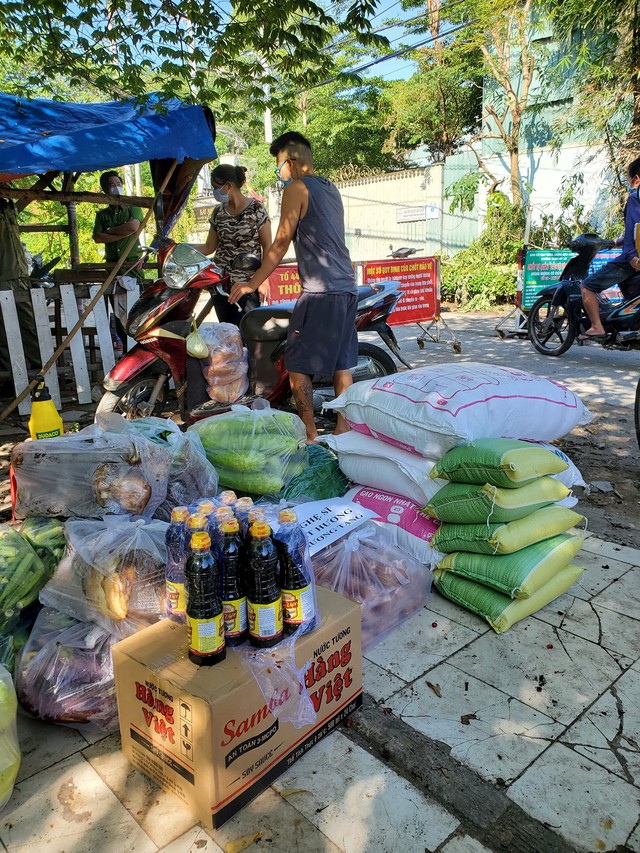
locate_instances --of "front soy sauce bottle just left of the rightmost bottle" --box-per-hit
[247,521,283,649]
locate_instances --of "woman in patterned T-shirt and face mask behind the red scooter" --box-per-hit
[195,163,271,326]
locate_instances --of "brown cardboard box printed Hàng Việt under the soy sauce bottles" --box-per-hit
[113,587,362,828]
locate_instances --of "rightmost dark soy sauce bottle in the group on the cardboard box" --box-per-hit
[276,509,316,634]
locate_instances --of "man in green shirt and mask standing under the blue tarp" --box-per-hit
[93,172,144,346]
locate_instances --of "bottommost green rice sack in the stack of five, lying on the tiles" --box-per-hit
[433,565,584,634]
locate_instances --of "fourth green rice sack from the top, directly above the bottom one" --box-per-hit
[438,533,584,598]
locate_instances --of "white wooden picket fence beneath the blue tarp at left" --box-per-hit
[0,284,139,415]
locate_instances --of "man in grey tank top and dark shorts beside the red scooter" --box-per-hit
[229,131,358,443]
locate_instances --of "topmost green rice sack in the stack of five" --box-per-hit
[429,438,569,489]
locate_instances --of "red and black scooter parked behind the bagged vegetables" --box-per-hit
[98,239,411,422]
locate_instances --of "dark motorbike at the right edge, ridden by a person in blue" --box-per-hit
[527,234,640,356]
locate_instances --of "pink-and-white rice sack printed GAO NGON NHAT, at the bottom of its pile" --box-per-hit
[344,486,444,566]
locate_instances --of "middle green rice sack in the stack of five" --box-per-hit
[431,504,584,554]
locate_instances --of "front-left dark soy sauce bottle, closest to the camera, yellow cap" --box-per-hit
[185,531,227,666]
